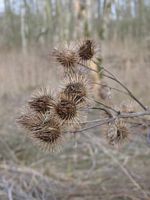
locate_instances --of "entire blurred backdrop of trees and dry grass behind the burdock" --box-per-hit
[0,0,150,200]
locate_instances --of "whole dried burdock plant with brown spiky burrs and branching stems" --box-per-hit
[17,39,150,150]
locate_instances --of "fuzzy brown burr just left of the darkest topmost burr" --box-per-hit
[52,46,78,72]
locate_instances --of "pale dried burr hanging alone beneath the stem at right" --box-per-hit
[107,120,130,147]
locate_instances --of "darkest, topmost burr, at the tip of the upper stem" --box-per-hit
[77,39,96,63]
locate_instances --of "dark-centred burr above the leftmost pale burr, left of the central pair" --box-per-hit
[28,88,55,113]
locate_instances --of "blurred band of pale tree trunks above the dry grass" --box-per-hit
[0,0,150,51]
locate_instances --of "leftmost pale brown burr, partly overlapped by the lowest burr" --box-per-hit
[17,112,44,131]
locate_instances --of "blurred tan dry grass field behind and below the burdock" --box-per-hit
[0,43,150,200]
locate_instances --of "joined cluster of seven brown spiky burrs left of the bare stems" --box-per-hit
[17,39,97,150]
